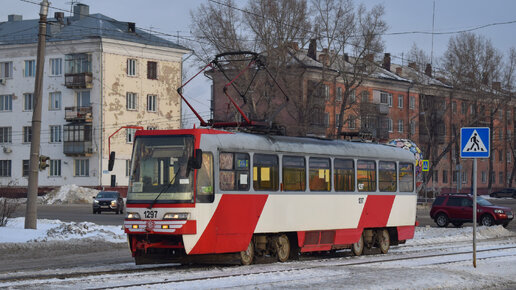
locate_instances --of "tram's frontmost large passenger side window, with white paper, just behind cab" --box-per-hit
[219,152,249,190]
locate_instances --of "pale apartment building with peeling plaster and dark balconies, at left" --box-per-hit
[0,4,188,192]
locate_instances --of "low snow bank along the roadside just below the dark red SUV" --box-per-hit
[407,226,514,245]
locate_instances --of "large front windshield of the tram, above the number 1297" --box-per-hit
[127,136,194,203]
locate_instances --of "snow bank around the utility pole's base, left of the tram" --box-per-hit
[0,219,126,243]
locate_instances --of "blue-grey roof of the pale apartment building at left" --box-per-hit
[0,4,189,50]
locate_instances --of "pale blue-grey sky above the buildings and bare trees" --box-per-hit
[0,0,516,124]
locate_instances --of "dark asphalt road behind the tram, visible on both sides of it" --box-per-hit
[14,198,516,232]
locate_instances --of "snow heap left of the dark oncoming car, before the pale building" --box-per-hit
[41,184,99,204]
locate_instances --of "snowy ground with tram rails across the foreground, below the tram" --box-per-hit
[0,226,516,289]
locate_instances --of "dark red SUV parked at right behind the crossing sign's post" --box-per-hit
[430,193,514,227]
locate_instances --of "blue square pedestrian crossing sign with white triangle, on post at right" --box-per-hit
[460,127,491,158]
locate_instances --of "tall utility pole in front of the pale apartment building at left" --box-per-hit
[25,0,49,229]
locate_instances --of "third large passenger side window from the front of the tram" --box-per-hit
[283,156,306,191]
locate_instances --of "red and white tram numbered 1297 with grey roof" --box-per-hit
[124,129,417,264]
